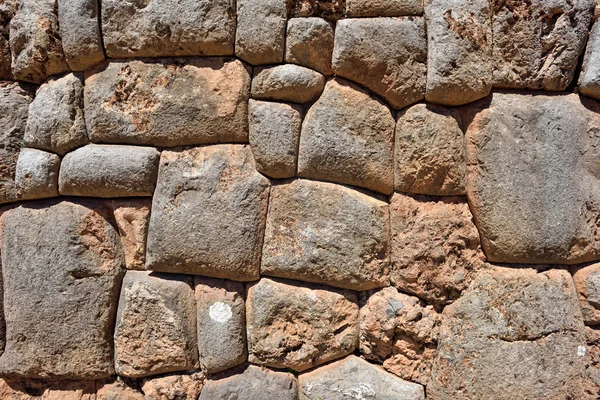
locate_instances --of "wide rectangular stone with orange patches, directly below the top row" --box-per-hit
[84,58,250,147]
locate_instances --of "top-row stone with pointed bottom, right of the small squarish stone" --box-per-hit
[333,17,427,109]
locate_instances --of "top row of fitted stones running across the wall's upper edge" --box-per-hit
[0,0,600,109]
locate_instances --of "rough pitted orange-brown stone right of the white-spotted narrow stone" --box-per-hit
[246,278,358,371]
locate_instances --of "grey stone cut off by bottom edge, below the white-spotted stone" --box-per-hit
[198,365,298,400]
